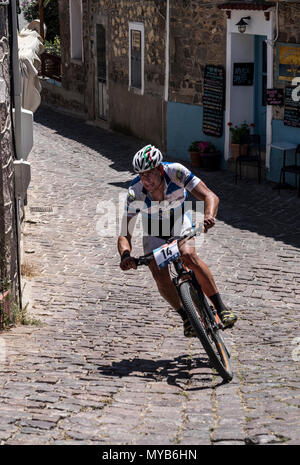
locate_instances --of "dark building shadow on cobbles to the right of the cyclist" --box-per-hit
[201,172,300,248]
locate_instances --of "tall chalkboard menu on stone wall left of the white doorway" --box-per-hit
[202,65,225,137]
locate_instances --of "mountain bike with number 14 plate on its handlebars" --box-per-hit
[134,228,233,381]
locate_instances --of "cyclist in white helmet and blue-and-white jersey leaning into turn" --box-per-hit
[118,145,237,337]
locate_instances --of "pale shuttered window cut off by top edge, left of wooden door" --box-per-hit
[69,0,83,62]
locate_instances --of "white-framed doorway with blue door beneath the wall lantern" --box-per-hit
[224,7,274,169]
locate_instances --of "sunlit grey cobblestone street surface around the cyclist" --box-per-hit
[0,108,300,445]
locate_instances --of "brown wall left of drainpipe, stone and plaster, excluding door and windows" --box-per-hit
[51,0,166,145]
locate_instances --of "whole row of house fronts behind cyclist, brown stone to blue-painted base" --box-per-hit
[44,0,300,183]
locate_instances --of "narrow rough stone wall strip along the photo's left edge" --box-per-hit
[0,7,18,324]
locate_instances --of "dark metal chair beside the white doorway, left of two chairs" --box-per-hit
[235,134,261,184]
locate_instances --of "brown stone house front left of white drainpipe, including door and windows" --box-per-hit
[53,0,166,146]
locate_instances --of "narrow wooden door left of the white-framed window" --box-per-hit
[96,24,108,120]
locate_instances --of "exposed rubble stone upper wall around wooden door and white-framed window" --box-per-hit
[89,0,166,96]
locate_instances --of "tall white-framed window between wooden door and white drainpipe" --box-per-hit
[129,23,144,94]
